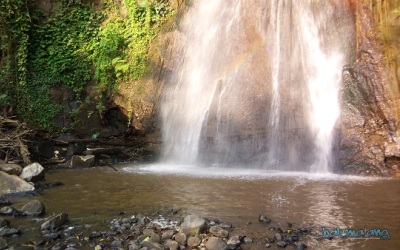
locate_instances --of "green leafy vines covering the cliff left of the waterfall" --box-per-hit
[0,0,172,129]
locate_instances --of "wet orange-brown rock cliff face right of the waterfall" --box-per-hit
[338,1,400,175]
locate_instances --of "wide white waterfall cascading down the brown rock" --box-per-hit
[161,0,353,172]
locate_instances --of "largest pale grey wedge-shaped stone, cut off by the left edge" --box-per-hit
[0,172,35,194]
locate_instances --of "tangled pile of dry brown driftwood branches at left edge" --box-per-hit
[0,116,32,164]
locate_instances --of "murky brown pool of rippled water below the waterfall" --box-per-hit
[7,165,400,249]
